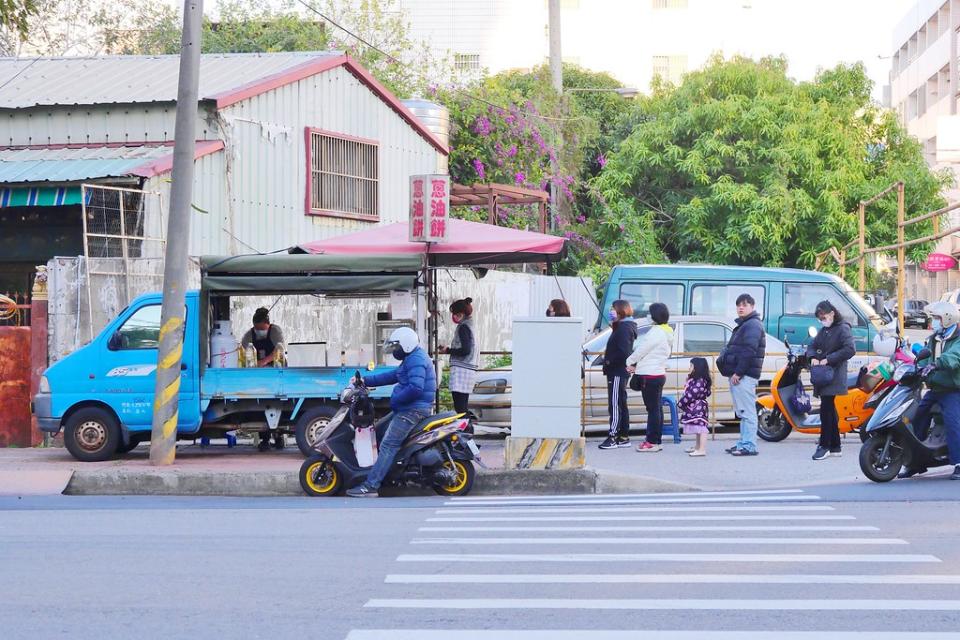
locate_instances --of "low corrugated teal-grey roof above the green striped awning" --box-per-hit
[0,145,173,184]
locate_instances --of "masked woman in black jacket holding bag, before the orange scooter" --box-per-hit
[807,300,857,460]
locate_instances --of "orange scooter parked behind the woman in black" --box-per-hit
[757,327,913,442]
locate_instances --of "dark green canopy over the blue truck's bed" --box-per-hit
[200,253,423,294]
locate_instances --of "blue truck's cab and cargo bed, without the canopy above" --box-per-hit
[33,291,390,461]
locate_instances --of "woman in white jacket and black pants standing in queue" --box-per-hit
[627,302,673,452]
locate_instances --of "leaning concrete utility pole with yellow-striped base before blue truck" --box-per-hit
[150,0,203,465]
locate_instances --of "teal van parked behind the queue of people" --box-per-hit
[597,264,883,351]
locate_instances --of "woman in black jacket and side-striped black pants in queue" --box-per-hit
[600,300,637,449]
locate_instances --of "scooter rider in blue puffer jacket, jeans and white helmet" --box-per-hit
[347,327,437,498]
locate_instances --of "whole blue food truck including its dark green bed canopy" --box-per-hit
[32,254,421,461]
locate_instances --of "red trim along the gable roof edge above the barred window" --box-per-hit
[205,56,450,155]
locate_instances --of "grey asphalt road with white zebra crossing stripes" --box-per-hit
[0,480,960,640]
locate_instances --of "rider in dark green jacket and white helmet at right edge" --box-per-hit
[899,301,960,480]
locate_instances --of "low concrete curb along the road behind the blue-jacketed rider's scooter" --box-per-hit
[64,468,699,497]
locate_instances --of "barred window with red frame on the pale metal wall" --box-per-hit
[307,129,380,222]
